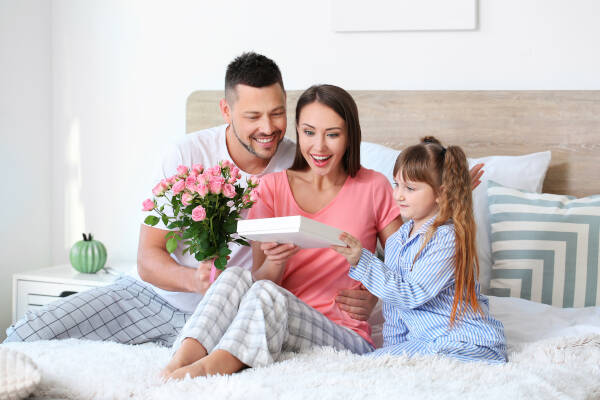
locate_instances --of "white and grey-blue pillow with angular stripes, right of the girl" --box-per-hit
[488,182,600,307]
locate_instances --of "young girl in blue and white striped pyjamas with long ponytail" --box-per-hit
[333,137,506,362]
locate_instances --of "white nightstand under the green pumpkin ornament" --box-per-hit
[12,262,137,323]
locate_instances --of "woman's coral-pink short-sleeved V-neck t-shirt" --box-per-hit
[248,168,400,343]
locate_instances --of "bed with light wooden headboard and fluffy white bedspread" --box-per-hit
[4,91,600,399]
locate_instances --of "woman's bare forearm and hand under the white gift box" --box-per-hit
[252,242,300,285]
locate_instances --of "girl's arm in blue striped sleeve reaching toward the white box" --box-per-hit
[340,230,455,309]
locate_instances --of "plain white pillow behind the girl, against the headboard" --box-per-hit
[360,141,551,292]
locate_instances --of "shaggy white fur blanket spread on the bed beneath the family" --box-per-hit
[4,335,600,400]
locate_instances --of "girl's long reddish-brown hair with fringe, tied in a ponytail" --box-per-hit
[394,136,482,325]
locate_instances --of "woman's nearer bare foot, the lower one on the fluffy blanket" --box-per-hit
[168,350,246,379]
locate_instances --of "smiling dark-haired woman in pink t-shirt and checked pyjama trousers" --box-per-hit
[163,85,402,379]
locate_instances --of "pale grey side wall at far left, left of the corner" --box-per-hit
[0,0,52,341]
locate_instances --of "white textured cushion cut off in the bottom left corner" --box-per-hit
[0,346,41,400]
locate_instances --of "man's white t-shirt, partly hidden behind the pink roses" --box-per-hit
[145,125,296,312]
